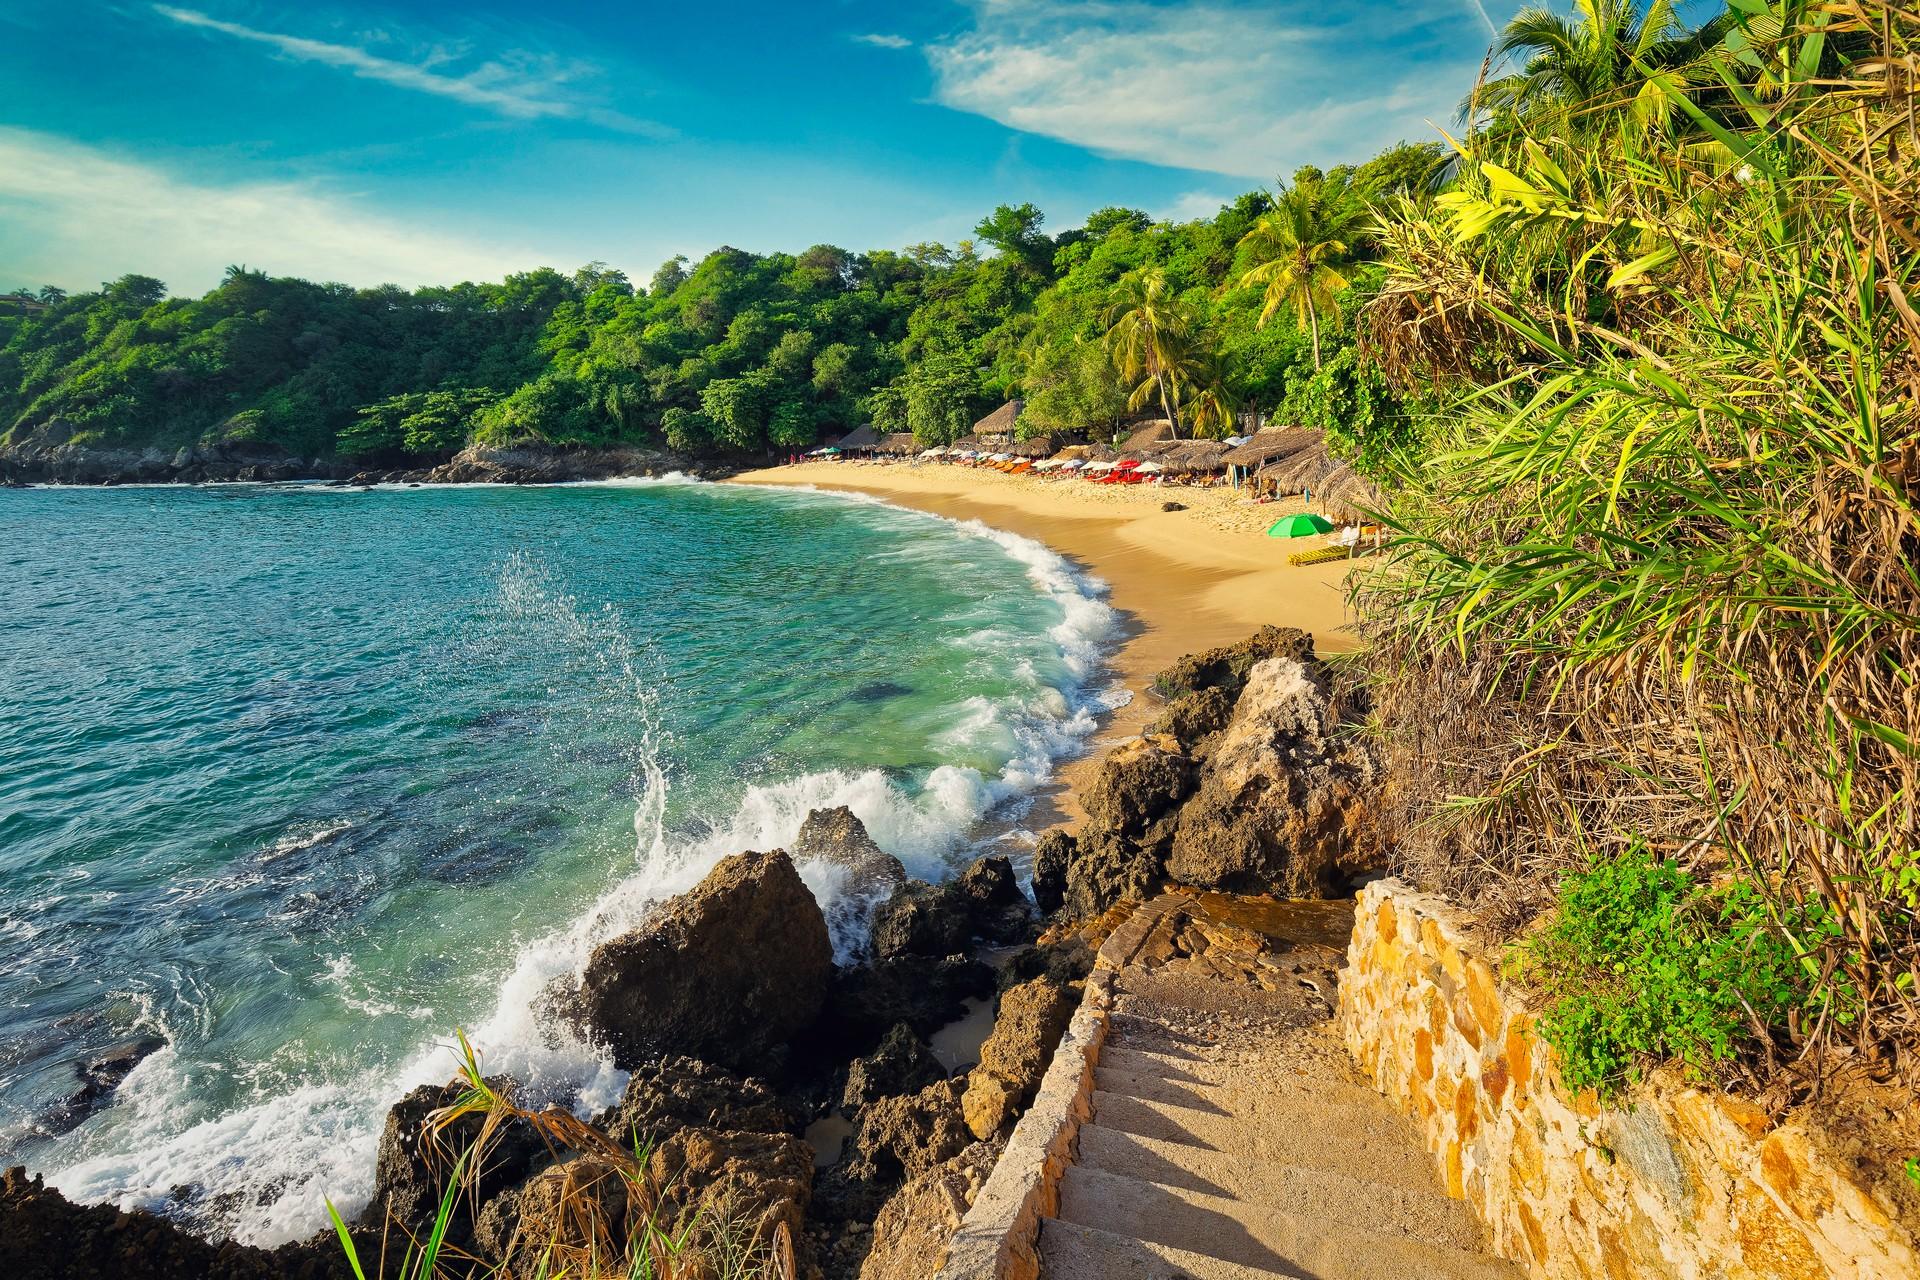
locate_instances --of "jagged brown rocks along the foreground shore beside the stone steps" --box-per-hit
[0,628,1379,1280]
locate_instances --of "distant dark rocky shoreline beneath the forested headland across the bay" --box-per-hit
[0,439,748,487]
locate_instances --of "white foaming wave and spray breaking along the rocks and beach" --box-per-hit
[48,476,1123,1245]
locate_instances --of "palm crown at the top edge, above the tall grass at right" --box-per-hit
[1461,0,1722,132]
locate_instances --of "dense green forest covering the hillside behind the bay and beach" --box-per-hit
[0,146,1440,461]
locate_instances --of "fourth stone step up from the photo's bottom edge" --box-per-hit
[1092,1090,1434,1192]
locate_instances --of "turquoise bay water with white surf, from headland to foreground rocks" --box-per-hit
[0,482,1114,1244]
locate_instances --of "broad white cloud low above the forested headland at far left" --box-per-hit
[0,125,549,294]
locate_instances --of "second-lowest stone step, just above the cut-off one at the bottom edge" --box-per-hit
[1056,1167,1521,1280]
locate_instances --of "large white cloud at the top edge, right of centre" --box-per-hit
[927,0,1486,178]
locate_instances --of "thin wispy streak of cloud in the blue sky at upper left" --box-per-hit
[154,4,674,138]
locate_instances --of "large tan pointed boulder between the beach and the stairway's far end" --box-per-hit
[1167,654,1380,898]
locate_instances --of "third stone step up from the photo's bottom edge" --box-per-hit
[1075,1125,1482,1251]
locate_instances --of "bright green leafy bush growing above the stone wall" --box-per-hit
[1517,846,1820,1092]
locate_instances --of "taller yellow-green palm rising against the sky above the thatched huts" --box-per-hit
[1240,173,1367,370]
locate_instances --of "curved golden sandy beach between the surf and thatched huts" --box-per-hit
[735,462,1369,819]
